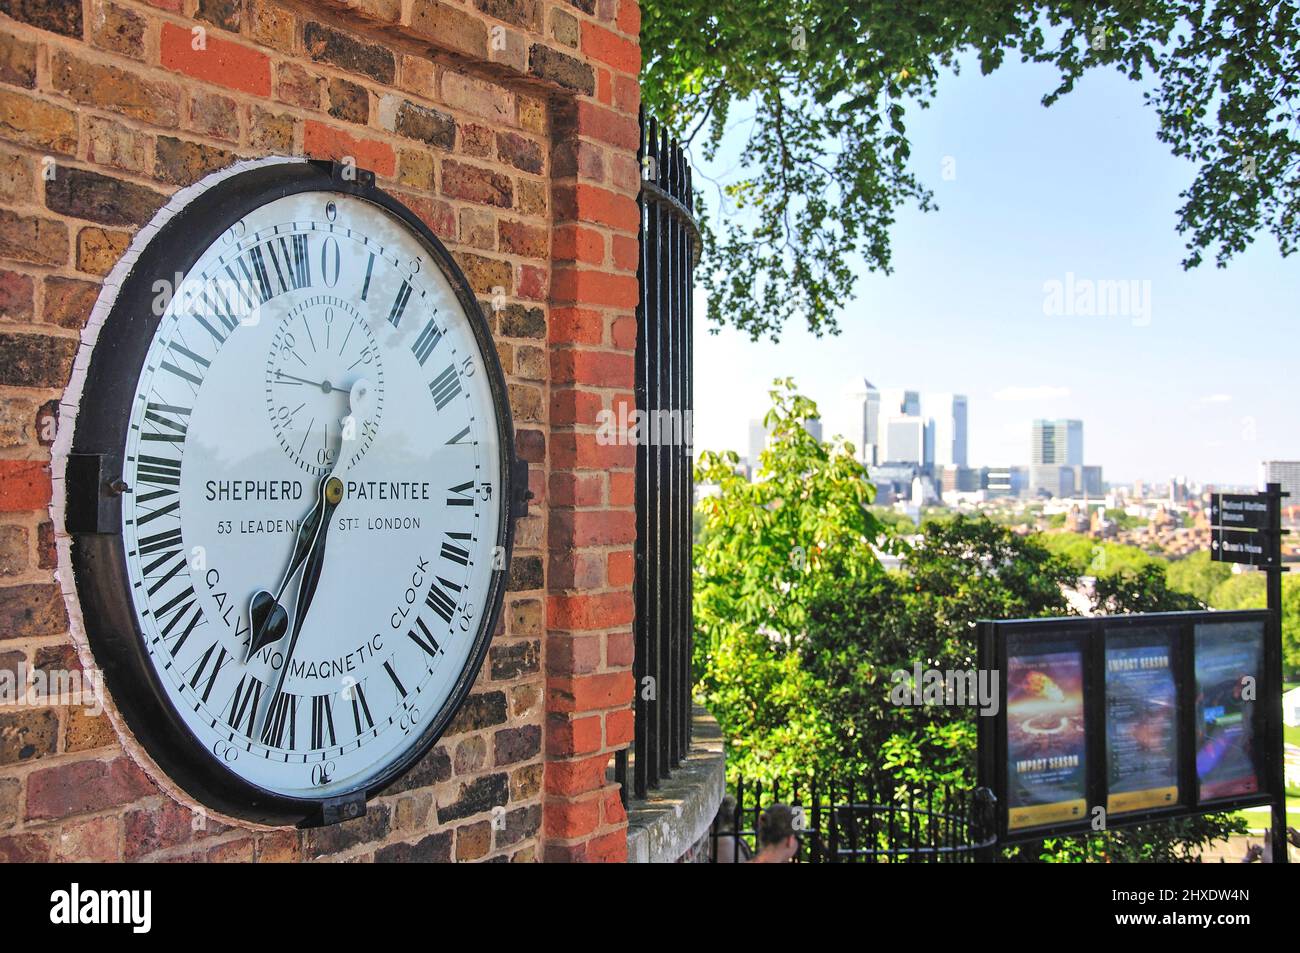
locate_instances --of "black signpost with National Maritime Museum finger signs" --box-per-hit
[1210,484,1287,863]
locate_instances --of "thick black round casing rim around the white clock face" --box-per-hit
[65,160,527,827]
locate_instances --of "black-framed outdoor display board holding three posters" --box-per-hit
[979,611,1282,841]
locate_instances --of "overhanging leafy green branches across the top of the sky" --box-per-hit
[641,0,1300,338]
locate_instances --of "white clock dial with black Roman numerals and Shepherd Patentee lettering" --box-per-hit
[114,185,503,798]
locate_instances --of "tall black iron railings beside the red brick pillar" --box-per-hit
[615,114,699,802]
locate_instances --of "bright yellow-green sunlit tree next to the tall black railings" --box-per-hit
[694,381,893,780]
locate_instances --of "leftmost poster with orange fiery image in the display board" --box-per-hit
[1006,640,1088,831]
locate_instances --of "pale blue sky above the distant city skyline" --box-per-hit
[693,51,1300,485]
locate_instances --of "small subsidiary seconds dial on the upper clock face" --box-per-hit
[267,295,384,476]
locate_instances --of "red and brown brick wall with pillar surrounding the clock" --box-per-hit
[0,0,640,861]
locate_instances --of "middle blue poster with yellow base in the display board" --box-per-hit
[1106,628,1178,814]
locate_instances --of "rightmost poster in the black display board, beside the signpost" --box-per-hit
[1196,621,1264,801]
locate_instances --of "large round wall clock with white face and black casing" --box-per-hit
[64,159,528,826]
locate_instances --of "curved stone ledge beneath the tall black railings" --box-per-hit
[628,707,727,863]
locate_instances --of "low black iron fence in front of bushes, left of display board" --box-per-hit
[706,781,997,863]
